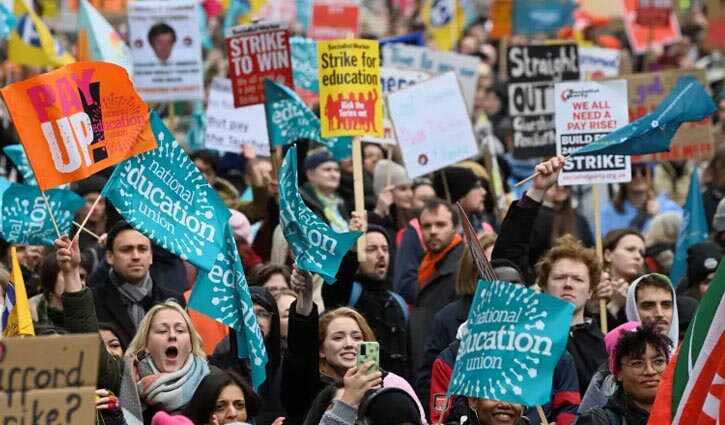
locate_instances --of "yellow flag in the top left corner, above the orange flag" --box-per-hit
[8,0,75,67]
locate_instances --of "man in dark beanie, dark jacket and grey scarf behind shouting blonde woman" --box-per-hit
[93,222,186,341]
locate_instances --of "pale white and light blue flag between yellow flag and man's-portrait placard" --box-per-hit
[78,0,133,75]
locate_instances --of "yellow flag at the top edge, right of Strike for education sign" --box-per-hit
[421,0,466,50]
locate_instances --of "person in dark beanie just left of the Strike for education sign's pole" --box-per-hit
[300,150,350,232]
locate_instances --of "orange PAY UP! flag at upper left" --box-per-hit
[2,62,156,190]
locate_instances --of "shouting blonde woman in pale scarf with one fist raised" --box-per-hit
[55,236,209,425]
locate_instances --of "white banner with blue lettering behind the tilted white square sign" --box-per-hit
[383,44,481,114]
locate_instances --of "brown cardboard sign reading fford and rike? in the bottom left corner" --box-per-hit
[0,334,101,425]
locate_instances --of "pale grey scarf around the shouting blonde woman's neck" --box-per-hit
[119,354,209,424]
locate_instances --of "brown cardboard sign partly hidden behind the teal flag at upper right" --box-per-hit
[622,70,715,163]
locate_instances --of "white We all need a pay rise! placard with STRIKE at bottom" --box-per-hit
[554,80,632,186]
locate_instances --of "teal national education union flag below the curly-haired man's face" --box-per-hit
[448,281,574,406]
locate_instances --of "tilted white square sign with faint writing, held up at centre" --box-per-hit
[388,72,478,179]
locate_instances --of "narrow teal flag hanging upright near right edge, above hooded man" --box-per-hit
[670,167,709,286]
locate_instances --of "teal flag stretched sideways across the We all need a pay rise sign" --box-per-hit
[572,75,716,155]
